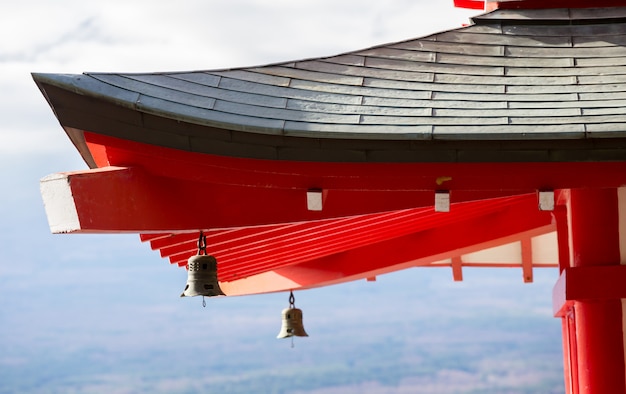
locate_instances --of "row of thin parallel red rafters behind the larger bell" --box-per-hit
[146,194,536,280]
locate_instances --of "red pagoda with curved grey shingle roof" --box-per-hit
[33,0,626,394]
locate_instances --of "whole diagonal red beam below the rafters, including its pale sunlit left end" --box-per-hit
[172,194,555,295]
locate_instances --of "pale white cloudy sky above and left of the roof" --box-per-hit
[0,0,480,157]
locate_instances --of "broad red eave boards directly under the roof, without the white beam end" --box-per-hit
[50,133,626,239]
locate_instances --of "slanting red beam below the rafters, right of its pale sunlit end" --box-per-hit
[268,198,554,286]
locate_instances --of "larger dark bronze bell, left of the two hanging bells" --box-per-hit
[180,255,225,297]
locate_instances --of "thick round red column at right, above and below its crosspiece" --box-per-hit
[569,189,626,394]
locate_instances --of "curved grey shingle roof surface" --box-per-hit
[35,7,626,161]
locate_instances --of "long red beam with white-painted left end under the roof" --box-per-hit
[41,167,540,232]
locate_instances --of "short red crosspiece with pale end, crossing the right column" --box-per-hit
[552,265,626,317]
